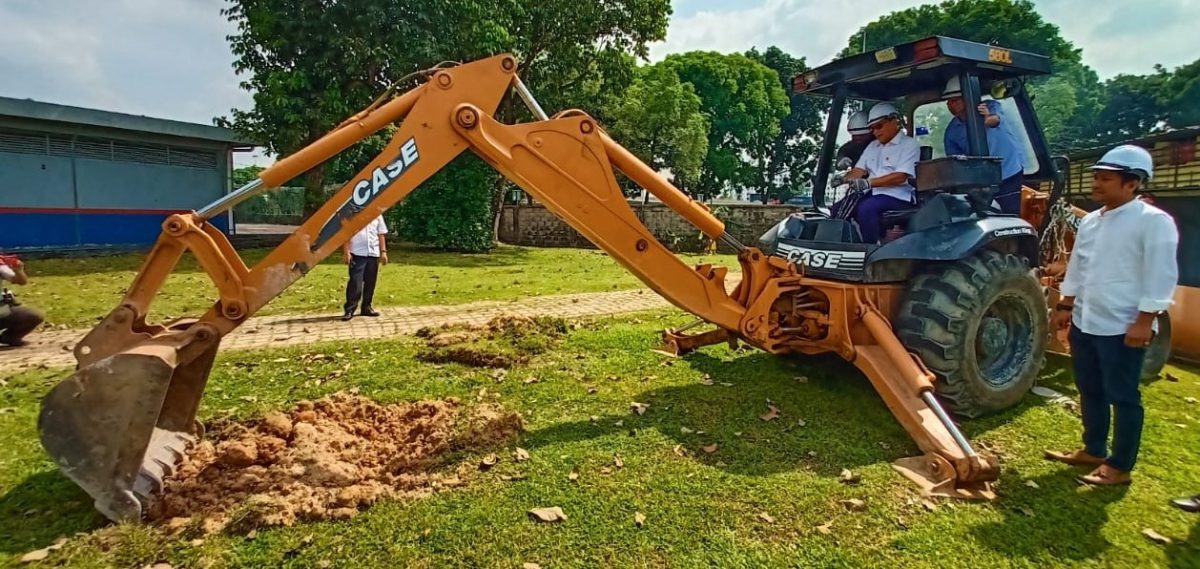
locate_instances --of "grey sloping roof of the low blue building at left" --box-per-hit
[0,97,260,146]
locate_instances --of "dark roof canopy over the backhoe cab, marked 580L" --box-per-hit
[792,36,1050,101]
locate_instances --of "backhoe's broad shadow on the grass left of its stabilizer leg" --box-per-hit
[522,352,1037,478]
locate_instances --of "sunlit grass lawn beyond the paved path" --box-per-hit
[18,246,737,328]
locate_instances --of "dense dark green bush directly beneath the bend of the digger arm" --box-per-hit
[389,154,499,252]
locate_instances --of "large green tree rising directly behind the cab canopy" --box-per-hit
[841,0,1103,150]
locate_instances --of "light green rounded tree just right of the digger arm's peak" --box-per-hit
[606,64,708,190]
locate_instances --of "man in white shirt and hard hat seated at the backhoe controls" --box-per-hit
[830,102,920,242]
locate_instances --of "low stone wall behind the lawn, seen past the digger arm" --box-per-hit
[498,204,800,252]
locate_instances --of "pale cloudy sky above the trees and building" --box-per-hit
[0,0,1200,163]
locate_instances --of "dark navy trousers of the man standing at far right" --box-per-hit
[1070,325,1146,471]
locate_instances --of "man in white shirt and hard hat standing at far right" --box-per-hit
[1046,145,1180,485]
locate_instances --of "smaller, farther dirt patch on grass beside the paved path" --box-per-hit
[416,316,566,367]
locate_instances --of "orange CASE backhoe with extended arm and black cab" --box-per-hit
[38,37,1061,520]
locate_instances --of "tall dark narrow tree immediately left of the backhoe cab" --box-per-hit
[746,46,822,202]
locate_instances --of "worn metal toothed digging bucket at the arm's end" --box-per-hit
[37,333,218,521]
